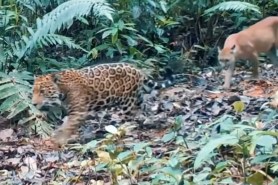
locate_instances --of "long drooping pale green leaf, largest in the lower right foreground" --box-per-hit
[194,135,239,169]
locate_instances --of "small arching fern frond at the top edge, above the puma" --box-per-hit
[204,1,261,14]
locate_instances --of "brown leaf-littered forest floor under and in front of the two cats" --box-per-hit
[0,64,278,184]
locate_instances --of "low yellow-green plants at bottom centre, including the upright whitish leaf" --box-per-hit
[70,123,191,184]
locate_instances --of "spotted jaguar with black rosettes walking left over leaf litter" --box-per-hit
[32,63,176,145]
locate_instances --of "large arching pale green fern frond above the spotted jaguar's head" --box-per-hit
[13,0,113,61]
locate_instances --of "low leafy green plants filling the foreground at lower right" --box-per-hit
[64,107,278,184]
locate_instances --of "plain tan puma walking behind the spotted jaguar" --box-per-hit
[218,16,278,89]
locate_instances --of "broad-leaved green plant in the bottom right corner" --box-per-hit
[194,112,278,184]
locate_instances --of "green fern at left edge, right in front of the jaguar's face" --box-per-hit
[0,71,52,137]
